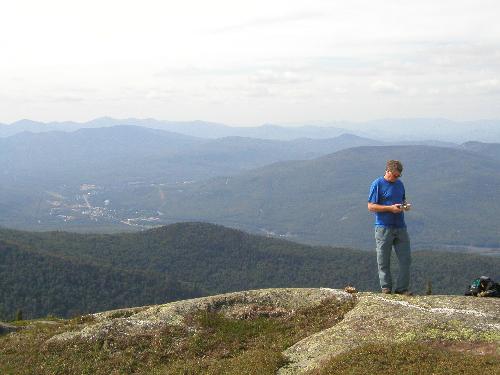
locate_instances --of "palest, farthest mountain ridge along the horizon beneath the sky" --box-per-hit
[0,117,500,143]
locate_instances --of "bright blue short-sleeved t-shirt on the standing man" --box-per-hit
[368,177,406,228]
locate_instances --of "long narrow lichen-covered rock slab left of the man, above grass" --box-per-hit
[47,288,353,345]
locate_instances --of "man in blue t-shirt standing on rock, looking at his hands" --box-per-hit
[368,160,412,295]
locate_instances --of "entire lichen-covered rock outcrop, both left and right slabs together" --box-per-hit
[35,288,500,375]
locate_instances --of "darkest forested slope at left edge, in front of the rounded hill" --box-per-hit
[0,240,201,320]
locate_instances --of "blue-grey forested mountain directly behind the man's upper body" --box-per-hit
[149,146,500,249]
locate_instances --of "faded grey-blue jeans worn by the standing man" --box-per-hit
[375,226,411,293]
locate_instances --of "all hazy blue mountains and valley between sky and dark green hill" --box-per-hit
[0,118,500,254]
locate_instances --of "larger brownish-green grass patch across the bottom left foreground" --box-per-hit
[0,299,354,375]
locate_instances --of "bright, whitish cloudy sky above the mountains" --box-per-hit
[0,0,500,126]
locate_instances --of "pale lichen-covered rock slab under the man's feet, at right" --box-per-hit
[278,293,500,375]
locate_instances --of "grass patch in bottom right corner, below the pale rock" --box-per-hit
[308,342,500,375]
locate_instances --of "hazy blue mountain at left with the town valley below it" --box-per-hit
[0,126,390,231]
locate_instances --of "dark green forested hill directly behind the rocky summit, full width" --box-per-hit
[0,223,500,319]
